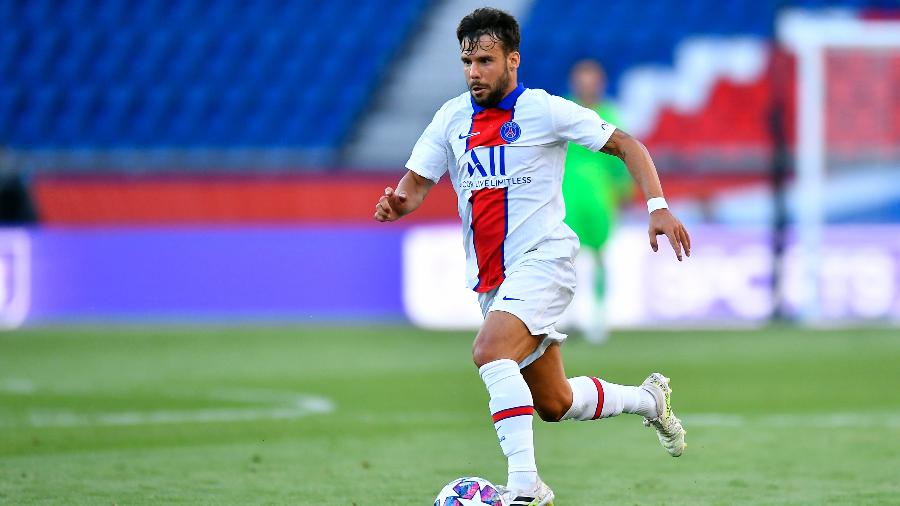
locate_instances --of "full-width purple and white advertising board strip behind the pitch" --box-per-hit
[0,225,900,328]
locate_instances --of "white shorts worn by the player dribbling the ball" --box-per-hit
[478,258,575,369]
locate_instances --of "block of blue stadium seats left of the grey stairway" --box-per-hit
[0,0,428,149]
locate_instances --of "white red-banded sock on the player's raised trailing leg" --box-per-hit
[562,376,657,420]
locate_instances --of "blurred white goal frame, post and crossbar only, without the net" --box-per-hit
[777,11,900,325]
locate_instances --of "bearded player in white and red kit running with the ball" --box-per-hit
[374,8,691,506]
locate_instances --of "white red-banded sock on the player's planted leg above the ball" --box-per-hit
[478,359,537,490]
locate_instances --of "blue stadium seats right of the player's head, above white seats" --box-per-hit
[522,0,898,99]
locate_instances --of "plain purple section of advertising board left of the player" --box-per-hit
[0,226,403,323]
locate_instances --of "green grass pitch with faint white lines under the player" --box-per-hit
[0,326,900,506]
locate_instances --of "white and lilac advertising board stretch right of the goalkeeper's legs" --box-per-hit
[613,226,900,324]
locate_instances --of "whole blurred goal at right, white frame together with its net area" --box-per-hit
[778,11,900,324]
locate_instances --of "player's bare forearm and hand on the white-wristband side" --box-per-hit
[600,129,691,262]
